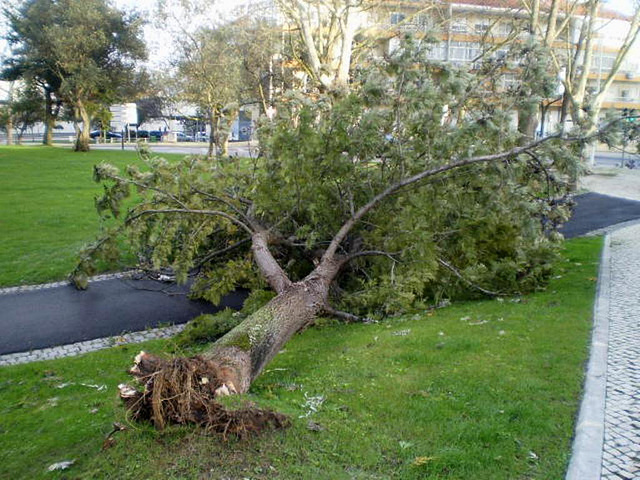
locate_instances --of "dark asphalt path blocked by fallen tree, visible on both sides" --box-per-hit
[0,193,640,355]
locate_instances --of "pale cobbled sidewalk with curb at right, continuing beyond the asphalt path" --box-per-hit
[566,170,640,480]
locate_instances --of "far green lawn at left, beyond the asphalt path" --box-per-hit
[0,147,179,287]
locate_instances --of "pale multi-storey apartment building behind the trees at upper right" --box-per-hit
[367,0,640,134]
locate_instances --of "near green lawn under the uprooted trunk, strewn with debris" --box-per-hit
[0,238,601,480]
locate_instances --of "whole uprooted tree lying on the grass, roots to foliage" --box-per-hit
[74,43,616,433]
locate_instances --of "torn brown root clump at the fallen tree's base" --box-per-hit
[119,352,290,437]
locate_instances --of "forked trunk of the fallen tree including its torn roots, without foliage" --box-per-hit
[120,231,341,433]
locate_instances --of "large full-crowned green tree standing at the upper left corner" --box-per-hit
[2,0,146,151]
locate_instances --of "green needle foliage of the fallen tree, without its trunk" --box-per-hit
[74,39,576,316]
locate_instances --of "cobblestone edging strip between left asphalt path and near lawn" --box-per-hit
[0,325,185,366]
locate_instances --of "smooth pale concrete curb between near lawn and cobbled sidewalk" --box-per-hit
[566,234,611,480]
